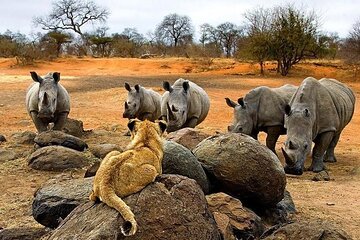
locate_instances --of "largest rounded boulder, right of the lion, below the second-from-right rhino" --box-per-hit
[193,133,286,208]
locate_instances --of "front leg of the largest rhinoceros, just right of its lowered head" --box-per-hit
[309,132,334,172]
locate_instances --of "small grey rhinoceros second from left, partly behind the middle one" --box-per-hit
[123,83,161,121]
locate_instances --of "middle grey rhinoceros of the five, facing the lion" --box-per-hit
[161,78,210,132]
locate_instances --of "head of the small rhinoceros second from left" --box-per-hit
[123,83,141,119]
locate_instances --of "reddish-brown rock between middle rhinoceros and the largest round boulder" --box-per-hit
[166,128,210,150]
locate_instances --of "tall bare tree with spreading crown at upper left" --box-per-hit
[33,0,109,36]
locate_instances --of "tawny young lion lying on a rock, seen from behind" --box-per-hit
[89,120,166,236]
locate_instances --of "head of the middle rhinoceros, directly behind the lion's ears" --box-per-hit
[163,81,190,132]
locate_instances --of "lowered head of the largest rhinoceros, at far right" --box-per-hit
[281,105,312,175]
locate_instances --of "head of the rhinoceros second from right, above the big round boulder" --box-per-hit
[225,98,254,135]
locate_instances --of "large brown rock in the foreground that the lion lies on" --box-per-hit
[48,175,221,240]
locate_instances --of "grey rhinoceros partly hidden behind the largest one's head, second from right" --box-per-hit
[225,84,296,154]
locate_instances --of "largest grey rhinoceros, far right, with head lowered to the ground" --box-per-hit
[282,77,355,175]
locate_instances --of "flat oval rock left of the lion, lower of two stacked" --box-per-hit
[28,146,91,171]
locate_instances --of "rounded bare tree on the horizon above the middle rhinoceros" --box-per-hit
[155,13,194,47]
